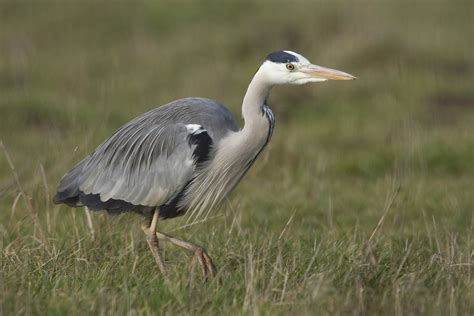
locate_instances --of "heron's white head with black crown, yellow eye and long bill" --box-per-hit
[258,50,356,85]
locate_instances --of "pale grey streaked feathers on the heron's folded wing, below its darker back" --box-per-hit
[79,124,194,206]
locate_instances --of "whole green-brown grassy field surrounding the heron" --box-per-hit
[0,0,474,315]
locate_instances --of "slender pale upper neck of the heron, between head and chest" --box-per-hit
[242,70,272,130]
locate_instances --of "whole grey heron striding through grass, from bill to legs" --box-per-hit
[54,51,355,275]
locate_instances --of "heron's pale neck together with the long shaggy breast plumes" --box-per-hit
[182,66,273,218]
